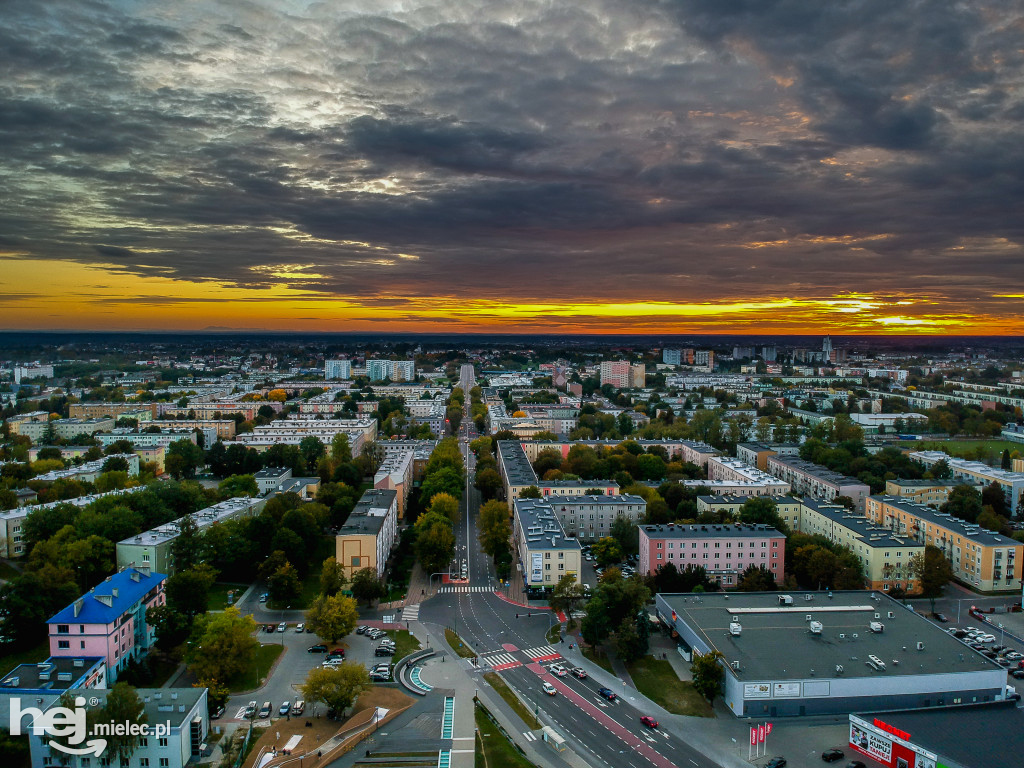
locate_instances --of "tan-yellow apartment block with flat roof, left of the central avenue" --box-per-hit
[335,488,398,579]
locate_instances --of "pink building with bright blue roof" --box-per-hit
[47,567,167,683]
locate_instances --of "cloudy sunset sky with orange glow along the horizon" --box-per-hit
[0,0,1024,335]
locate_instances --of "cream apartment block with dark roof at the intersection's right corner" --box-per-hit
[512,499,583,589]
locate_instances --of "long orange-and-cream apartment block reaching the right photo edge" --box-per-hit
[866,496,1024,592]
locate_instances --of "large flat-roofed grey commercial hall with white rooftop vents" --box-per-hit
[655,591,1007,718]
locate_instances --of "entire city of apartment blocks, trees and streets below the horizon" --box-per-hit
[0,335,1024,768]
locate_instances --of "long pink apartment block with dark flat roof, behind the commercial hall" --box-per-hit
[639,523,785,588]
